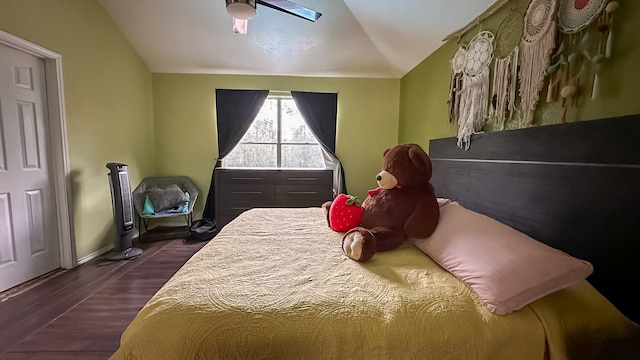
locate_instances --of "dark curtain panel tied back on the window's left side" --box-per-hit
[202,89,269,219]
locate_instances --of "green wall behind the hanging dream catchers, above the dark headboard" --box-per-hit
[398,0,640,149]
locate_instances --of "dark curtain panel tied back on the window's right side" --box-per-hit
[291,91,347,197]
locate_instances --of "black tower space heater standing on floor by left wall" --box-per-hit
[107,163,142,260]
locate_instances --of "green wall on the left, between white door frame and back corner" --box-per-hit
[0,0,155,259]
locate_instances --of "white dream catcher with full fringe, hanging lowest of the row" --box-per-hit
[458,31,494,150]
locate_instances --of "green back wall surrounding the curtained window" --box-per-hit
[153,74,400,207]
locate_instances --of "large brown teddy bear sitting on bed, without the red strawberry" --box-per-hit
[322,144,440,262]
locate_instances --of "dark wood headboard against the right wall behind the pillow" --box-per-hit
[429,115,640,322]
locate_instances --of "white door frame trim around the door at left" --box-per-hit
[0,30,78,269]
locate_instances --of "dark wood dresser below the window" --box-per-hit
[214,168,333,228]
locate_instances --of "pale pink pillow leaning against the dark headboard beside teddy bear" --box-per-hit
[411,202,593,315]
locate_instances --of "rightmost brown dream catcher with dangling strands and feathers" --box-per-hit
[547,0,619,122]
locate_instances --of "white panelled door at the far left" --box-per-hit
[0,44,60,291]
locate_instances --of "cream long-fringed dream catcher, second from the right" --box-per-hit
[520,0,557,126]
